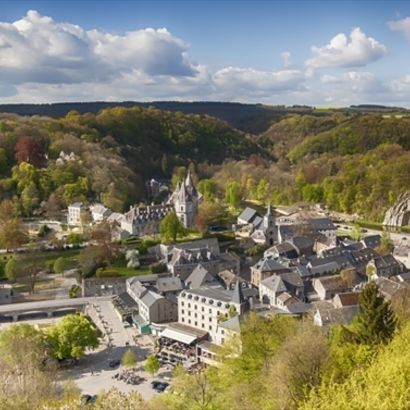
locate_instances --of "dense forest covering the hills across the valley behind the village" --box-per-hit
[0,103,410,221]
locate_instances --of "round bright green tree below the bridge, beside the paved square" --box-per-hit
[46,313,99,360]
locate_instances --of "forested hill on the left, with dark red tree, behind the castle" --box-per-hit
[0,107,269,216]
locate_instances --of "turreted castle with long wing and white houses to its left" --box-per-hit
[67,172,202,239]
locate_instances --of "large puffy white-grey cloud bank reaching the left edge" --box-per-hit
[0,10,197,93]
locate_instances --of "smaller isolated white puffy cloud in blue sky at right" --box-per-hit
[305,27,386,69]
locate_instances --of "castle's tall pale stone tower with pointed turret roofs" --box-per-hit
[167,171,202,228]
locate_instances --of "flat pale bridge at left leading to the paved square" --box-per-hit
[0,296,111,322]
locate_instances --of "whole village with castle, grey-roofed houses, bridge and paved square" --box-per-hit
[0,173,410,398]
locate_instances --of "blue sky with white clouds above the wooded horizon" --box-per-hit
[0,0,410,107]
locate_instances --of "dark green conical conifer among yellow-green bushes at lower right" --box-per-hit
[352,282,397,345]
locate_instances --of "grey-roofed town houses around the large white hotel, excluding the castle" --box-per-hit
[79,203,410,365]
